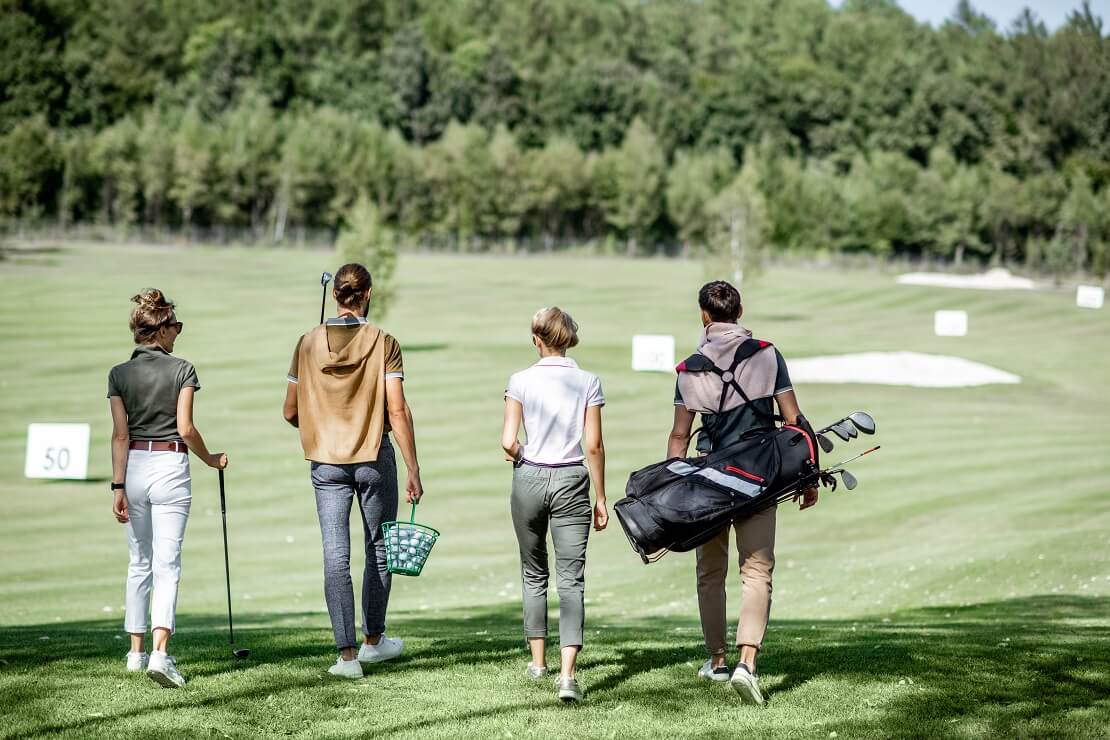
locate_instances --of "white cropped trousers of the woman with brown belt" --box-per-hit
[123,449,192,633]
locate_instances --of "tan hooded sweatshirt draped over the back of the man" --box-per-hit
[296,324,385,465]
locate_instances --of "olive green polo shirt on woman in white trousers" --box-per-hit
[108,344,201,442]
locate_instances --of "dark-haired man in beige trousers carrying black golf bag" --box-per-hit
[667,281,817,704]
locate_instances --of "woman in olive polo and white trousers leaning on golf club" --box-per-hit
[108,288,228,689]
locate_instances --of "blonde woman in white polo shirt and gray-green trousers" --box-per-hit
[501,307,609,701]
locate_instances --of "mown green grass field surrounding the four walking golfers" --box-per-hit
[0,246,1110,738]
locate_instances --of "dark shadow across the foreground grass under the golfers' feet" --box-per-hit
[0,596,1110,737]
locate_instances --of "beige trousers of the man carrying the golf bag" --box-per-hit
[697,507,776,656]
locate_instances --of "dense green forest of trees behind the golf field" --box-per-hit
[0,0,1110,274]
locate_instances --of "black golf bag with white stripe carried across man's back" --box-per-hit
[613,416,820,562]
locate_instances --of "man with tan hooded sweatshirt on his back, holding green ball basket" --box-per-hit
[283,263,424,679]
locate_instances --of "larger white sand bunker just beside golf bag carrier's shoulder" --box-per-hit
[788,352,1021,388]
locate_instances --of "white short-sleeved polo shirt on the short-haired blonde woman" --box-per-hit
[505,357,605,465]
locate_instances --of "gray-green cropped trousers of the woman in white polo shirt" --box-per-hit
[509,464,593,648]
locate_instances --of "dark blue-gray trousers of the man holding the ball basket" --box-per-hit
[312,438,397,650]
